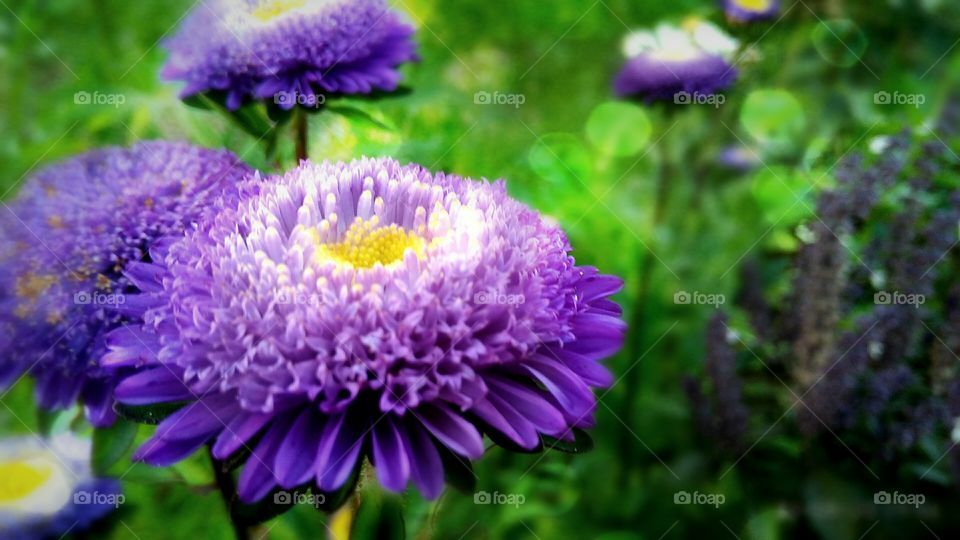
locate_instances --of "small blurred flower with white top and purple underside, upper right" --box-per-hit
[613,19,737,101]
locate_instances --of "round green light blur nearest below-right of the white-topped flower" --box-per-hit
[740,89,807,145]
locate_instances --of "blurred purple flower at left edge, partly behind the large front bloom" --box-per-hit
[0,141,251,425]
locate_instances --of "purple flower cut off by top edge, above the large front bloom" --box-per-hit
[163,0,416,110]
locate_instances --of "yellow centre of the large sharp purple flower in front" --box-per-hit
[318,217,424,268]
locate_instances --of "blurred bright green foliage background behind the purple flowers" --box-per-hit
[0,0,960,540]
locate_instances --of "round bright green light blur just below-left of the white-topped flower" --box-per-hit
[587,101,653,157]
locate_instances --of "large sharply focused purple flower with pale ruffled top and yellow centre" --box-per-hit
[109,159,625,501]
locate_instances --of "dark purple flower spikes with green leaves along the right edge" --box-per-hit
[685,99,960,473]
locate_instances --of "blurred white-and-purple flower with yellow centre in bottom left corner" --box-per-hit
[0,433,123,540]
